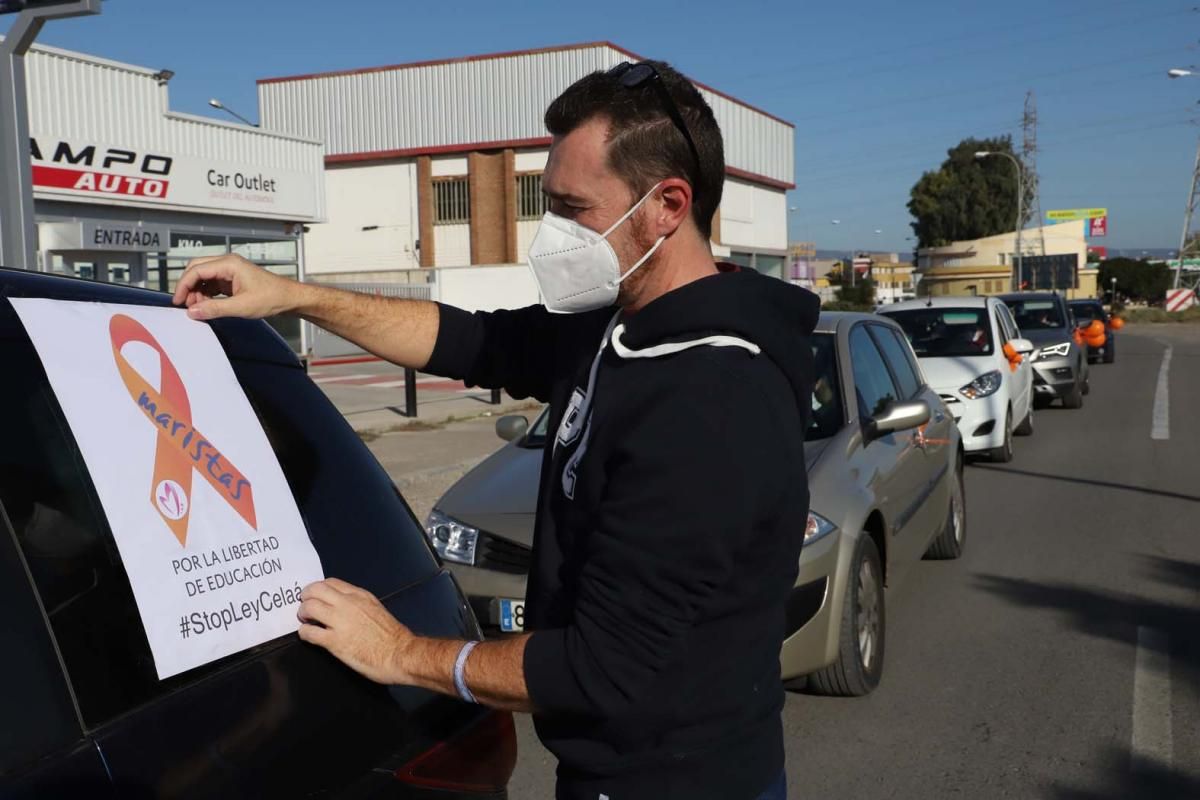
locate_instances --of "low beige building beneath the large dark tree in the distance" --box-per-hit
[916,219,1098,297]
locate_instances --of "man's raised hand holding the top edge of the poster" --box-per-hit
[175,255,304,319]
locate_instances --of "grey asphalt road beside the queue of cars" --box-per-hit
[510,326,1200,800]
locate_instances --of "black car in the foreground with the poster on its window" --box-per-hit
[0,270,516,800]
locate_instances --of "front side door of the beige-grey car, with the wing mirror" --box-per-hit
[850,323,925,584]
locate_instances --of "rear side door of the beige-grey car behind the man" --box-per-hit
[868,324,954,572]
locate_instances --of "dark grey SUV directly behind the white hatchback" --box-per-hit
[1000,291,1091,408]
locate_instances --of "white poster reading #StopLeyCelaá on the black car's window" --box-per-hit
[11,297,323,678]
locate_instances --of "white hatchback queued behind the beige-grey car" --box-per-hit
[880,296,1034,462]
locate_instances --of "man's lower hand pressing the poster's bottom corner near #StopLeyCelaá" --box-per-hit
[296,578,416,684]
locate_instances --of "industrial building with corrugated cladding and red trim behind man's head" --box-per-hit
[258,42,794,282]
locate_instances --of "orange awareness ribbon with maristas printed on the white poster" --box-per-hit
[108,314,258,545]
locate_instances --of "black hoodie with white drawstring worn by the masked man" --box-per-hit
[427,271,818,800]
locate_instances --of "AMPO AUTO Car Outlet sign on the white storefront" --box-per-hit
[30,137,316,219]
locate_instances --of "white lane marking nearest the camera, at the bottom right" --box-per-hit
[1130,626,1172,771]
